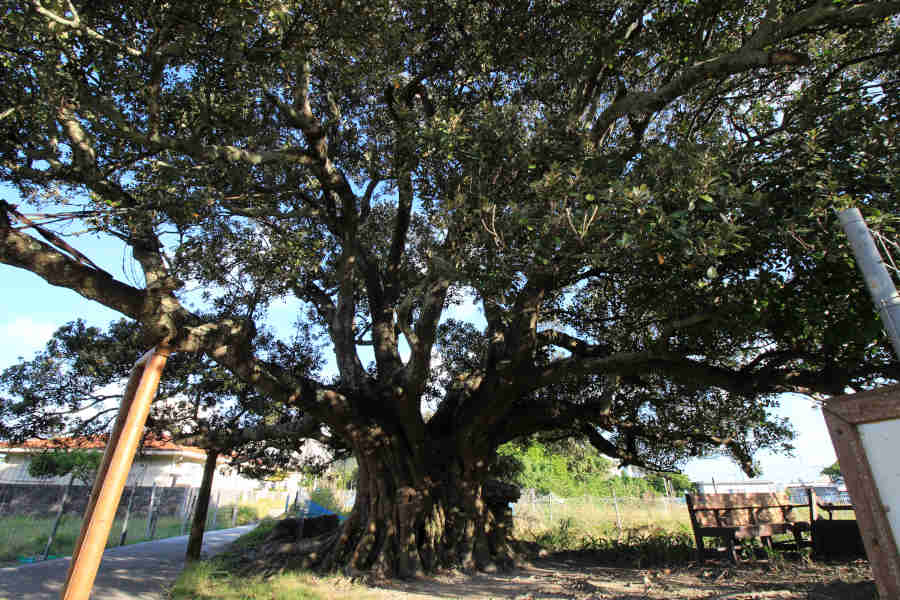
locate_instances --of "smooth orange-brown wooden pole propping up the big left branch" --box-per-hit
[60,348,170,600]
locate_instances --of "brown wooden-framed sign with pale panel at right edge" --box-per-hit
[822,385,900,598]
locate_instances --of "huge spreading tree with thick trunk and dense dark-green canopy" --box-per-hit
[0,0,900,575]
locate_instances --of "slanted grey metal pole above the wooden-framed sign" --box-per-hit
[838,208,900,358]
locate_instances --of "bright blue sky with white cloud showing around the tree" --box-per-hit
[0,191,836,483]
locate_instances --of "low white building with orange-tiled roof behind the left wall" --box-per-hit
[0,437,260,490]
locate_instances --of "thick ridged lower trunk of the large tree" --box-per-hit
[312,428,519,577]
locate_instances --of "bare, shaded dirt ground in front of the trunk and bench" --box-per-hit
[356,553,877,600]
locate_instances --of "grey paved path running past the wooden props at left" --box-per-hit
[0,525,254,600]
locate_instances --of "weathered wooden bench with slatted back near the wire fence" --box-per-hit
[685,493,812,562]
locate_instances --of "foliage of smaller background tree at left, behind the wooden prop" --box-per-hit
[0,319,324,477]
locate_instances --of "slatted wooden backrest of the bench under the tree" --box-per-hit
[687,492,799,527]
